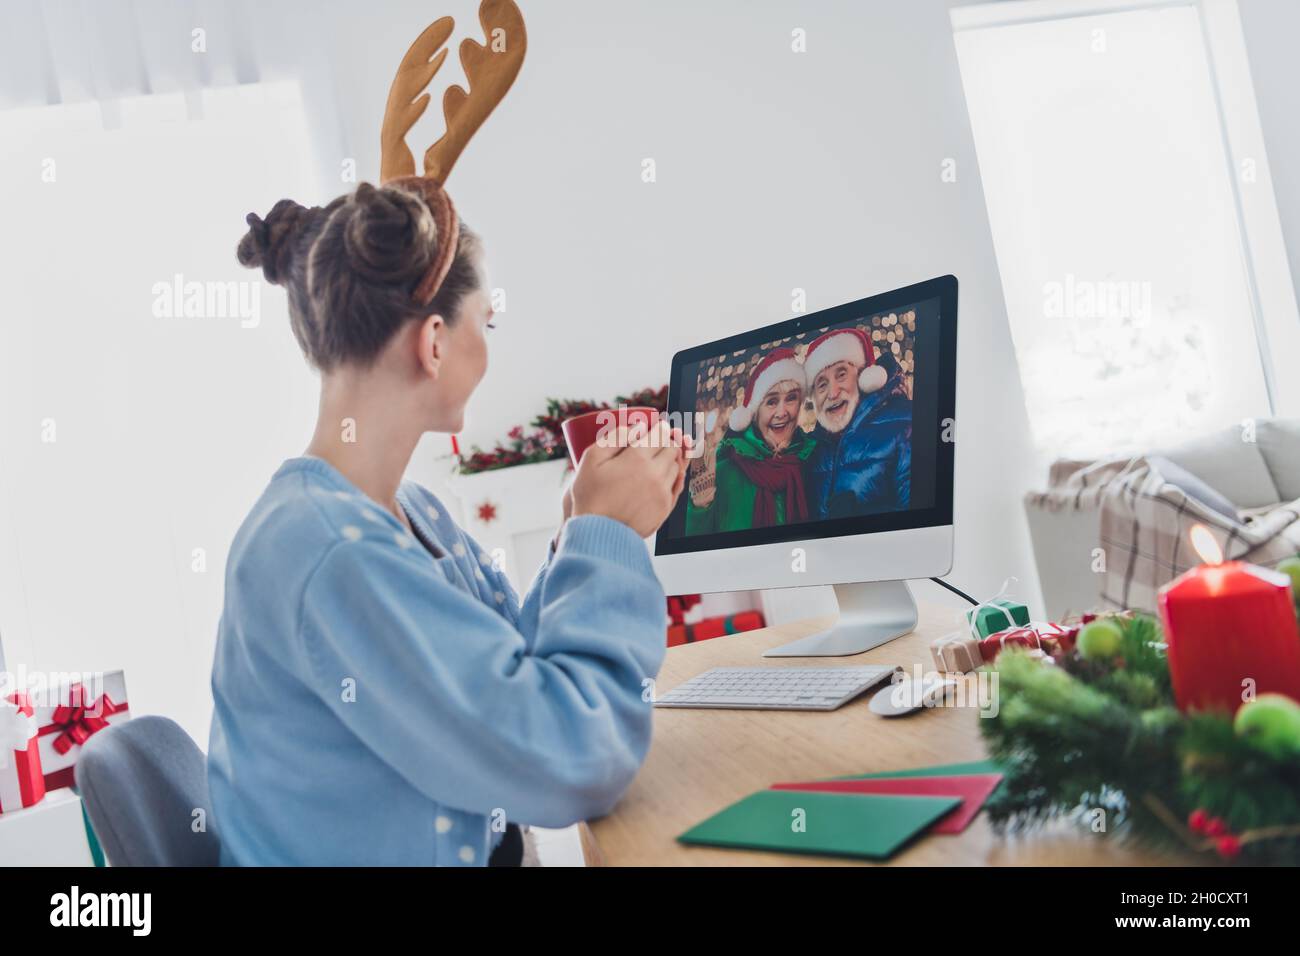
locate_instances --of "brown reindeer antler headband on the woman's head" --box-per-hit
[380,0,528,306]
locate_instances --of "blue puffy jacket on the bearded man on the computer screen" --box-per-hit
[807,363,911,518]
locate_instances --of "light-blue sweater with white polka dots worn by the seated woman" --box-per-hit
[208,458,664,866]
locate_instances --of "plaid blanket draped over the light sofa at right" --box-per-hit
[1034,458,1300,614]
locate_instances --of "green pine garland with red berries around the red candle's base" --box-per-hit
[980,614,1300,864]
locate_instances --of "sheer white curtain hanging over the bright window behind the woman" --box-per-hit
[0,0,488,743]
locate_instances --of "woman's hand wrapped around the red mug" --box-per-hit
[569,423,690,537]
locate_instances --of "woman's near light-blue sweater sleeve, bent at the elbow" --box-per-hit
[293,516,666,827]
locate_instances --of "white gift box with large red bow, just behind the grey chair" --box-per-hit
[35,671,131,791]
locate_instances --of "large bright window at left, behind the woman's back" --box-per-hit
[0,83,321,740]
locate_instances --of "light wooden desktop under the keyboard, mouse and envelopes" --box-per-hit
[585,606,1184,866]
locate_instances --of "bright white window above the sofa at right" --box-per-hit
[953,0,1297,458]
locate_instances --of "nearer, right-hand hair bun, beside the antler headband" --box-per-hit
[343,182,437,284]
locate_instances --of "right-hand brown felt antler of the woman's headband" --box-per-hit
[426,0,528,183]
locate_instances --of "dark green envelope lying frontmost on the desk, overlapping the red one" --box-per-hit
[677,790,961,860]
